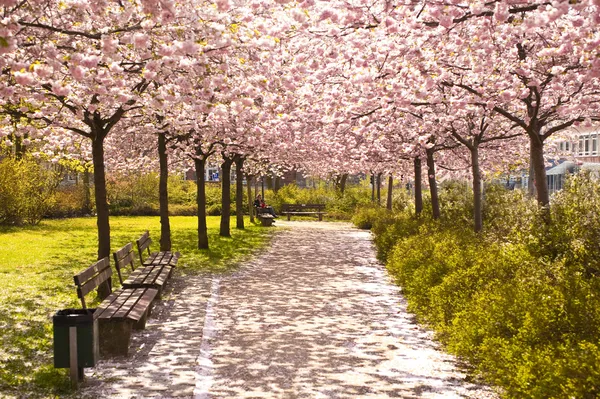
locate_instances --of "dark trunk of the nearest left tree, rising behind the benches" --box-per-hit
[92,133,111,299]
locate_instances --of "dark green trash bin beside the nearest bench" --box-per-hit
[52,309,100,369]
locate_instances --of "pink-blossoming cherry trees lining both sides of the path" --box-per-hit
[0,0,600,257]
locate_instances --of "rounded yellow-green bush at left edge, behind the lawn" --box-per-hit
[0,156,60,225]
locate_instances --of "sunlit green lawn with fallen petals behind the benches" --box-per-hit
[0,216,272,398]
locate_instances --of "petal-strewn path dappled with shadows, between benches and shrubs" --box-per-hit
[82,221,497,399]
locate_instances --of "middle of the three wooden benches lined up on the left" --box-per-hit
[113,243,174,298]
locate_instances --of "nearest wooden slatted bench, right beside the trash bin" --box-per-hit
[73,257,158,356]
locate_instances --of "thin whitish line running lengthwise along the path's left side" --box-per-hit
[194,277,220,399]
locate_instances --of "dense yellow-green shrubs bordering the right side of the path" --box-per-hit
[364,174,600,399]
